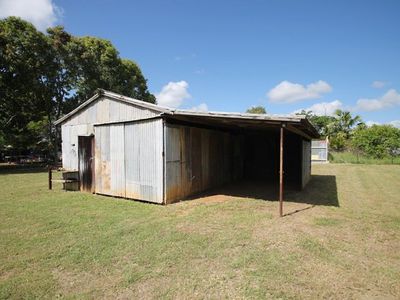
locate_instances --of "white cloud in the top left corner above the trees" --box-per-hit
[0,0,62,31]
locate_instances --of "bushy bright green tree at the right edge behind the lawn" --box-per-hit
[352,125,400,158]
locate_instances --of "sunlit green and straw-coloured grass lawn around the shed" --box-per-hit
[0,164,400,299]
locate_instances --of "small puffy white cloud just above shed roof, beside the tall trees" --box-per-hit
[156,80,192,108]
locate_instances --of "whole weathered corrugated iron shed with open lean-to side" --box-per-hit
[56,90,318,213]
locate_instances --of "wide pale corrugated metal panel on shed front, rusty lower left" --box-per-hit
[95,119,163,203]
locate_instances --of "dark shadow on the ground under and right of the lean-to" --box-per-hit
[186,175,339,210]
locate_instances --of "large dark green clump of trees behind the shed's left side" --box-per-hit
[0,17,156,158]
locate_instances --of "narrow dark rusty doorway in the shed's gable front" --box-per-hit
[78,136,94,193]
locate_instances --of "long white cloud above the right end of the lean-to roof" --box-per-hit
[267,80,332,103]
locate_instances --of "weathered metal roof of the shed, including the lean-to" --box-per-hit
[55,89,319,138]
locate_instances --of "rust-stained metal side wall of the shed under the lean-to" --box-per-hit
[165,124,243,203]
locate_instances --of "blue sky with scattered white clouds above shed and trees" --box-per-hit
[0,0,400,126]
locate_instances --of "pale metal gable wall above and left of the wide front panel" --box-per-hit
[61,96,158,171]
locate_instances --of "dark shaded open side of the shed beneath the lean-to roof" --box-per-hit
[166,117,303,203]
